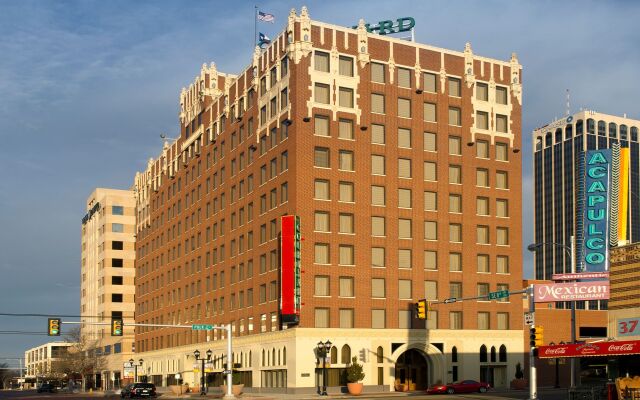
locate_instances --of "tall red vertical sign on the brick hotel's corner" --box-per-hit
[280,215,301,324]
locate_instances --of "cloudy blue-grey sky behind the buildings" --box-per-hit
[0,0,640,365]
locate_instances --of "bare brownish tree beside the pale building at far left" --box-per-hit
[51,327,105,388]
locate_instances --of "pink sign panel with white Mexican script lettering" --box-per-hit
[533,281,609,303]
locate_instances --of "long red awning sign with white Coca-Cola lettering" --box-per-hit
[538,340,640,358]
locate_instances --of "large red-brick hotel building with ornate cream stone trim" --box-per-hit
[135,8,524,392]
